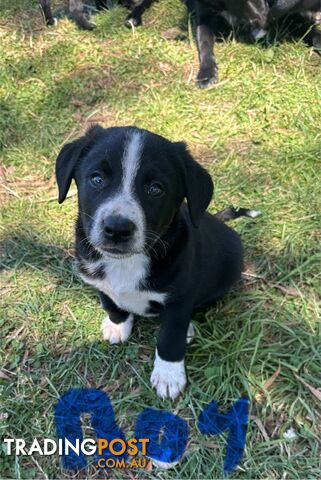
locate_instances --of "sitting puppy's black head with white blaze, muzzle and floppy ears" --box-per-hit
[56,126,213,258]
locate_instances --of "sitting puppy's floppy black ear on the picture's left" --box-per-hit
[56,125,104,203]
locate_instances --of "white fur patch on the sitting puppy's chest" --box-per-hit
[80,254,166,316]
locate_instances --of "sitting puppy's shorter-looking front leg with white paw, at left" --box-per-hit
[98,292,134,343]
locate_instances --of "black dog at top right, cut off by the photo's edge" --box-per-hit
[196,0,321,88]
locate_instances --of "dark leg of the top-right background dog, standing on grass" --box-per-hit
[196,2,217,88]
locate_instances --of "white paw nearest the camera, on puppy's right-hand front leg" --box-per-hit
[150,350,186,399]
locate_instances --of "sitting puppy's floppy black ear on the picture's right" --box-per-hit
[175,142,214,227]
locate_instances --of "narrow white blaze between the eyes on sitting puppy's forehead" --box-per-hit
[122,132,143,193]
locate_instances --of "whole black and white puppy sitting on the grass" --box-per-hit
[56,126,249,398]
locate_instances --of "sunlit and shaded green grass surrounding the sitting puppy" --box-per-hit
[0,0,321,480]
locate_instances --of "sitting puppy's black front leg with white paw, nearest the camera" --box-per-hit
[151,306,192,399]
